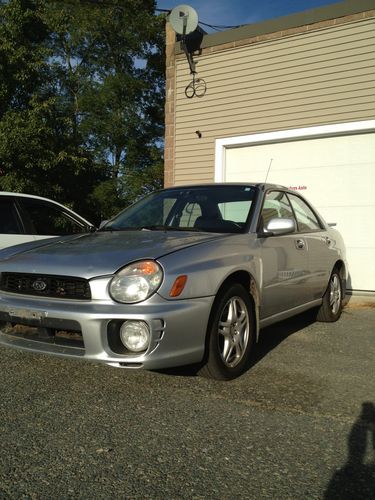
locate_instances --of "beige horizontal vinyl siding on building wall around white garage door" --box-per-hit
[174,18,375,184]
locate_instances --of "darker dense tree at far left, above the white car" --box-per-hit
[0,0,104,220]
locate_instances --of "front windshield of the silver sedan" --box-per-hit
[101,185,256,233]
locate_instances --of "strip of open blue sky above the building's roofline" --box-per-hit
[157,0,344,32]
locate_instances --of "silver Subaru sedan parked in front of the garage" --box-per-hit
[0,184,347,379]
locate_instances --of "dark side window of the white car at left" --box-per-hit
[19,198,85,236]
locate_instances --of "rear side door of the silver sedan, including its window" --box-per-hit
[288,193,335,299]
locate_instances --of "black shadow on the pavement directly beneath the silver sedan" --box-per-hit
[156,309,316,377]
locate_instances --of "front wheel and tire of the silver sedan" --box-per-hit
[199,284,254,380]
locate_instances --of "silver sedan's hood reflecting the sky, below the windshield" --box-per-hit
[0,231,227,279]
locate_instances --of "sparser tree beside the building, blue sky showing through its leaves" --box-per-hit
[45,0,164,217]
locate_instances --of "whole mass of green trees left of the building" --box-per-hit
[0,0,164,221]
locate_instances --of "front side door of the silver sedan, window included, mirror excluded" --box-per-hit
[258,190,311,319]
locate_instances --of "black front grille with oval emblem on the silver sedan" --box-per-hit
[0,273,91,300]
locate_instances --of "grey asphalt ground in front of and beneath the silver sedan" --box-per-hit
[0,307,375,499]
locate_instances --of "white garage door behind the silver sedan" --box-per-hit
[224,133,375,291]
